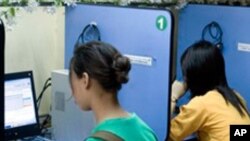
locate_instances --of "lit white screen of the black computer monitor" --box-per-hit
[4,78,36,129]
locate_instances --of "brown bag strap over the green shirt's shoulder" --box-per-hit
[89,130,124,141]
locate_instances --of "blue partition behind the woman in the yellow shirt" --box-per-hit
[177,5,250,109]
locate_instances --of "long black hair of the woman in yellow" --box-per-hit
[181,40,249,116]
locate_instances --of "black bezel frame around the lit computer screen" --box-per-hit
[4,71,41,140]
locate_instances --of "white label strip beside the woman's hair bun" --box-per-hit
[124,54,153,66]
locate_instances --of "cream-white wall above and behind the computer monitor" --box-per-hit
[5,7,65,115]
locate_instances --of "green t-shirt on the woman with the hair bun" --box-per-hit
[86,113,157,141]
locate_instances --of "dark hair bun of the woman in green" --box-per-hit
[112,55,131,83]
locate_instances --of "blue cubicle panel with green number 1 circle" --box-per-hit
[65,4,173,141]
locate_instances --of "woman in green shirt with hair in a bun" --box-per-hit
[70,41,157,141]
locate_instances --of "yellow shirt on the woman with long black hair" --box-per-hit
[170,90,250,141]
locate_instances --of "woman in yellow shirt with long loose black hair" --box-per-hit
[170,41,250,141]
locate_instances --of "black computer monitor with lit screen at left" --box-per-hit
[4,71,40,140]
